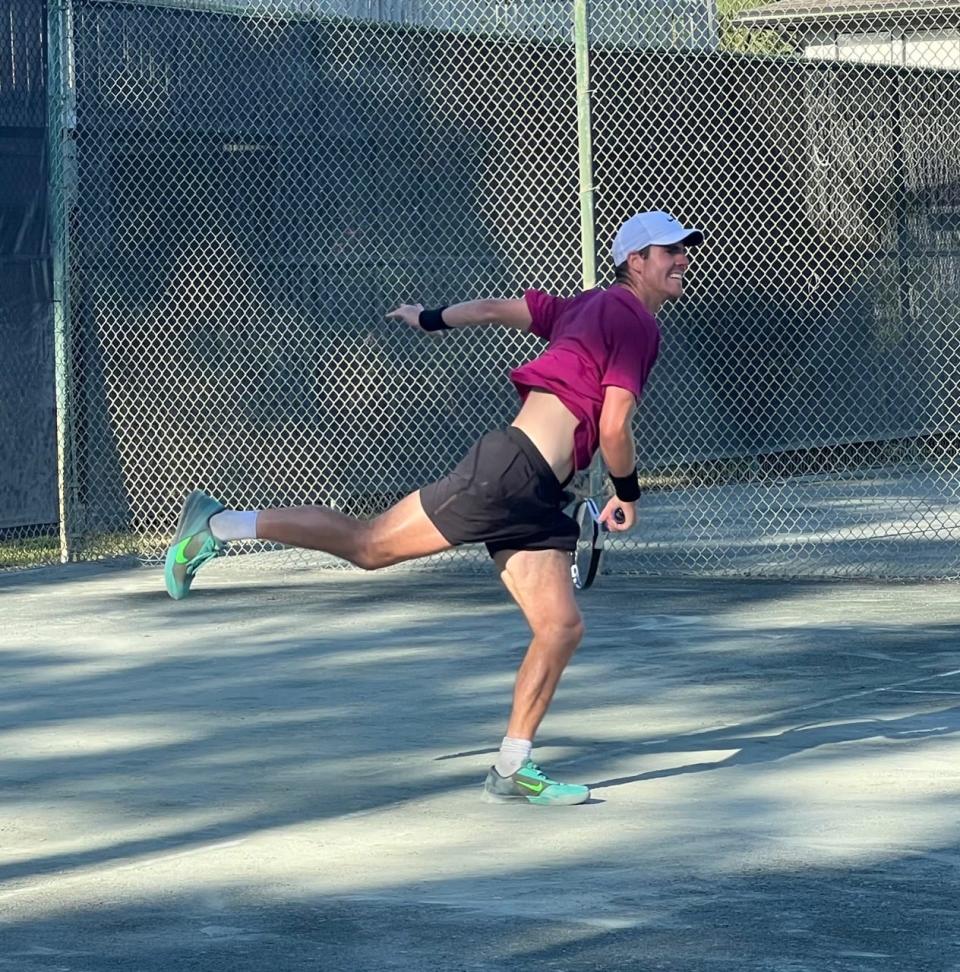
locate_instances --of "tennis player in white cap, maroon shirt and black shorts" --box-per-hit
[165,212,703,805]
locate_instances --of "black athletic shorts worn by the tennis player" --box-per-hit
[420,425,580,557]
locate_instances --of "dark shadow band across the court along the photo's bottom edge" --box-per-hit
[0,821,960,972]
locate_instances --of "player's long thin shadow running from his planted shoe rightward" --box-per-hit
[588,705,960,790]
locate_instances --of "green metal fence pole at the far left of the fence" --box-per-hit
[47,0,76,563]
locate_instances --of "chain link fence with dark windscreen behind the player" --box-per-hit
[9,0,960,578]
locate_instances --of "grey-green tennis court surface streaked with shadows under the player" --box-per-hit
[0,558,960,972]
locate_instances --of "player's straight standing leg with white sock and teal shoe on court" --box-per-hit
[483,550,590,805]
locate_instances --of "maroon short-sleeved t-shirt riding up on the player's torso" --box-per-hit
[510,286,660,469]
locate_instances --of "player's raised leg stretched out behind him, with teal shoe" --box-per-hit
[165,492,453,600]
